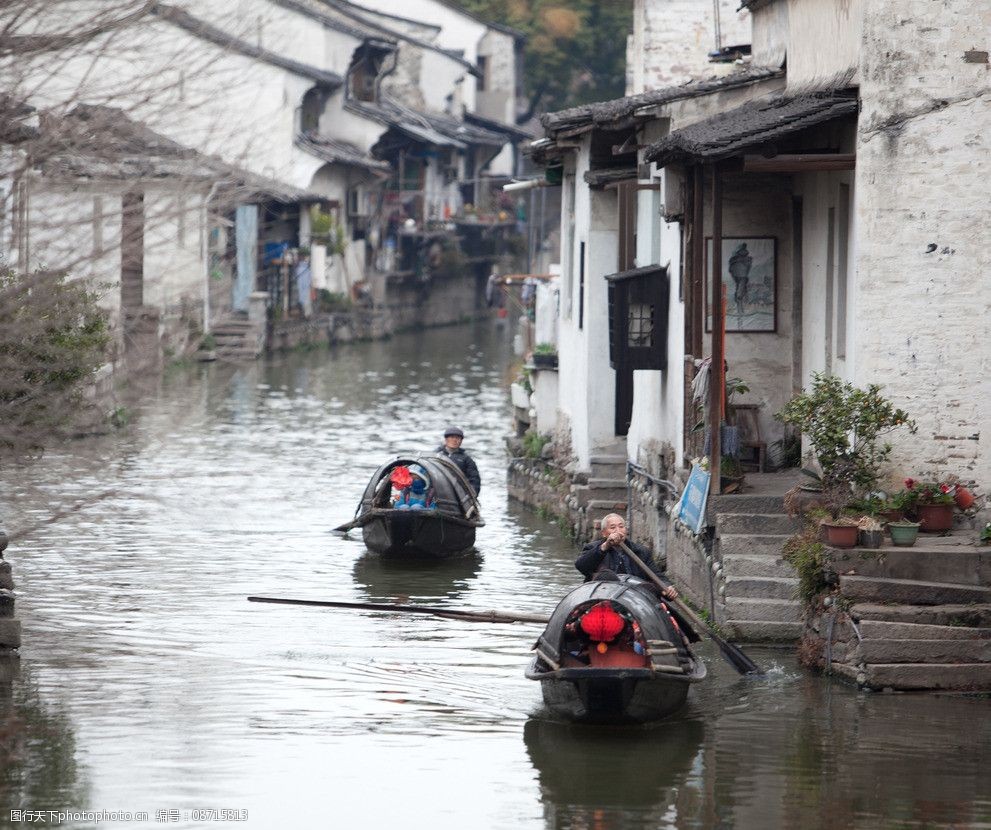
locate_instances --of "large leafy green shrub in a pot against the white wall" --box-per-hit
[774,373,915,517]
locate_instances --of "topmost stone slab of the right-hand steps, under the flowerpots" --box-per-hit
[830,546,991,586]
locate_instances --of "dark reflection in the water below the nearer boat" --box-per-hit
[523,718,705,830]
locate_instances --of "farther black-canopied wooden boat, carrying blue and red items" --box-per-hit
[339,455,485,559]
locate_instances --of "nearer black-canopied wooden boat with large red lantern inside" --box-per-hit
[526,576,706,723]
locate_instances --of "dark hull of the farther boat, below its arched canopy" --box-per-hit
[361,510,475,559]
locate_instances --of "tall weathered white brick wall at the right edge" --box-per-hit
[854,0,991,486]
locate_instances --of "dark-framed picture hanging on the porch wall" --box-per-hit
[703,236,778,332]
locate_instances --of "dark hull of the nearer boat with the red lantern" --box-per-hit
[527,660,693,723]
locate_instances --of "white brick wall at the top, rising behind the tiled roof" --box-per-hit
[627,0,750,95]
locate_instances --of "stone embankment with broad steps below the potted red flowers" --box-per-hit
[802,531,991,691]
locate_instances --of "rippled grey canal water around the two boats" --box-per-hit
[0,321,991,830]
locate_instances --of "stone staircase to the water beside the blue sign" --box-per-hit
[709,495,802,642]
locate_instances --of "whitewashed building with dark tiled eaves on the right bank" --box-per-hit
[532,0,991,639]
